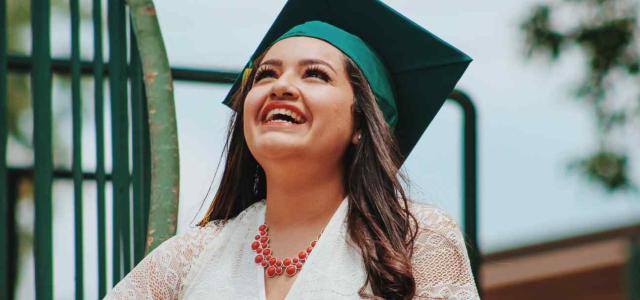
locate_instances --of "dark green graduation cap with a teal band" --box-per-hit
[223,0,471,159]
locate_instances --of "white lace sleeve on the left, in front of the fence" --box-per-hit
[104,223,220,300]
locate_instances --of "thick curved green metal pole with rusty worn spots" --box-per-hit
[128,0,180,252]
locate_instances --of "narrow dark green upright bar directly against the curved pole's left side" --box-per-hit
[129,27,149,264]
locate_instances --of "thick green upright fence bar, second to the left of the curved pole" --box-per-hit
[108,0,131,284]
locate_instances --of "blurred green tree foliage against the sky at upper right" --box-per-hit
[521,0,640,191]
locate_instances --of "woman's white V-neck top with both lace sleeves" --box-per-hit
[105,200,479,300]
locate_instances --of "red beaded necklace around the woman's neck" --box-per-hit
[251,224,318,278]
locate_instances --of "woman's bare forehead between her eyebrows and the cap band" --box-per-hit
[263,36,345,67]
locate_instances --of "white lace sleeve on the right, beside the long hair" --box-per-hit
[411,203,480,300]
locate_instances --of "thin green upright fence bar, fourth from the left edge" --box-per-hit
[92,0,107,299]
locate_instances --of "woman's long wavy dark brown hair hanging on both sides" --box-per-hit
[199,51,417,299]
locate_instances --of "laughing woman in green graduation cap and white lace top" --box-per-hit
[107,1,478,299]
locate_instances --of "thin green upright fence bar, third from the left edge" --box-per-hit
[69,0,84,300]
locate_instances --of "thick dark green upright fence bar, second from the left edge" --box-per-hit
[31,0,53,300]
